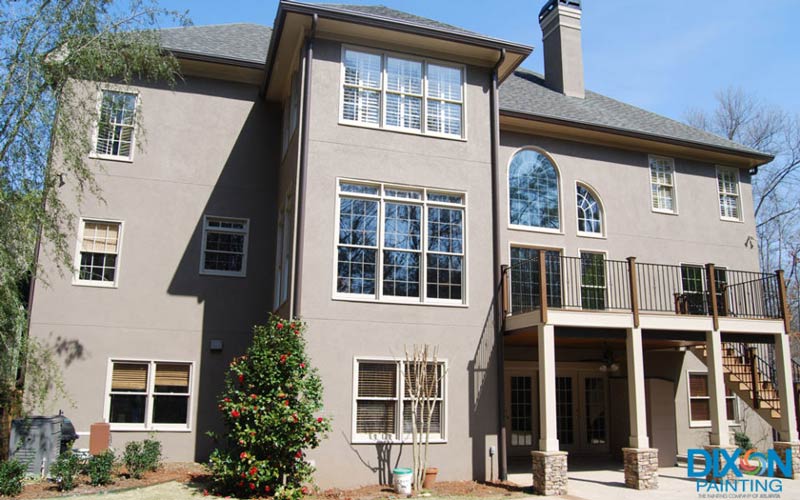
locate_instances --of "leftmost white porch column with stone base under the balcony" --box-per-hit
[531,324,567,495]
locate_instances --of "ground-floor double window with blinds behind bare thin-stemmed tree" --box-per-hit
[353,359,447,442]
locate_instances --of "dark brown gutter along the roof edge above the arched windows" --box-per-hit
[500,109,775,166]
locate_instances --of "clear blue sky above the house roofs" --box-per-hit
[160,0,800,120]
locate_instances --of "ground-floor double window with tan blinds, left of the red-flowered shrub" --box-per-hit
[105,361,192,429]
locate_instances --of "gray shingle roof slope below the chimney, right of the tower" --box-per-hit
[500,69,760,154]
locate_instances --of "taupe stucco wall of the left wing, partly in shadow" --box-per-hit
[31,78,277,460]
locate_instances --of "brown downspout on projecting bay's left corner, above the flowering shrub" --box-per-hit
[289,14,319,318]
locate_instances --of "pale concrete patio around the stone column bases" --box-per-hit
[508,458,800,500]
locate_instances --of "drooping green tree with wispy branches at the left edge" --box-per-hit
[0,0,185,451]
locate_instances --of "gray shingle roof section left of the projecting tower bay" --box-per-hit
[159,23,272,64]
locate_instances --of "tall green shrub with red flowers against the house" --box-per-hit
[208,316,330,499]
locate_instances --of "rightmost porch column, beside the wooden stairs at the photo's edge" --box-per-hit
[774,334,800,479]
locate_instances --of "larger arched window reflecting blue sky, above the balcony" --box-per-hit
[508,149,560,230]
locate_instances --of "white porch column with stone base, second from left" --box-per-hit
[622,328,658,490]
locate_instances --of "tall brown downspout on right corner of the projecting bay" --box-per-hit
[489,49,508,481]
